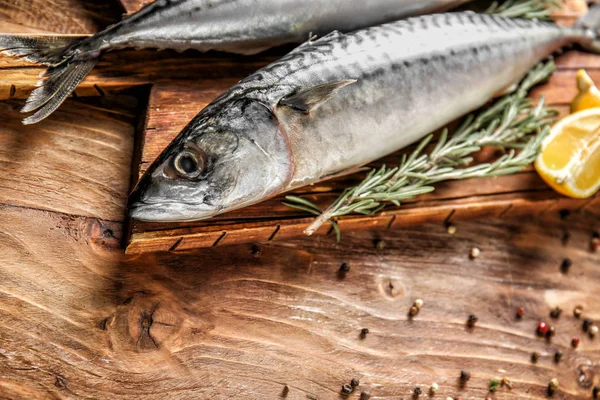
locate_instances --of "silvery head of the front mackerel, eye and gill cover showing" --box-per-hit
[129,99,292,222]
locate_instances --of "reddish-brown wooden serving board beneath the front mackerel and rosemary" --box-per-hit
[126,47,600,253]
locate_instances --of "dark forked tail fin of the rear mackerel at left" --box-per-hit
[0,35,99,125]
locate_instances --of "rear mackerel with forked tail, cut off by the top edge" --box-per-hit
[0,0,469,124]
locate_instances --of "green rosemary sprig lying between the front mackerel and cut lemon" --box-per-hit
[284,61,557,241]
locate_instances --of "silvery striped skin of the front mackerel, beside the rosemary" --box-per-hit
[131,13,597,221]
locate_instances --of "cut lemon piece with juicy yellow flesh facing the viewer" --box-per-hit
[535,108,600,199]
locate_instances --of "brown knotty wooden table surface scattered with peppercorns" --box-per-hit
[0,0,600,400]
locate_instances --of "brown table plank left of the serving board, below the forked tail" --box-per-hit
[0,96,137,221]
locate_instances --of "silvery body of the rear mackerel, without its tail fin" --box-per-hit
[97,0,469,54]
